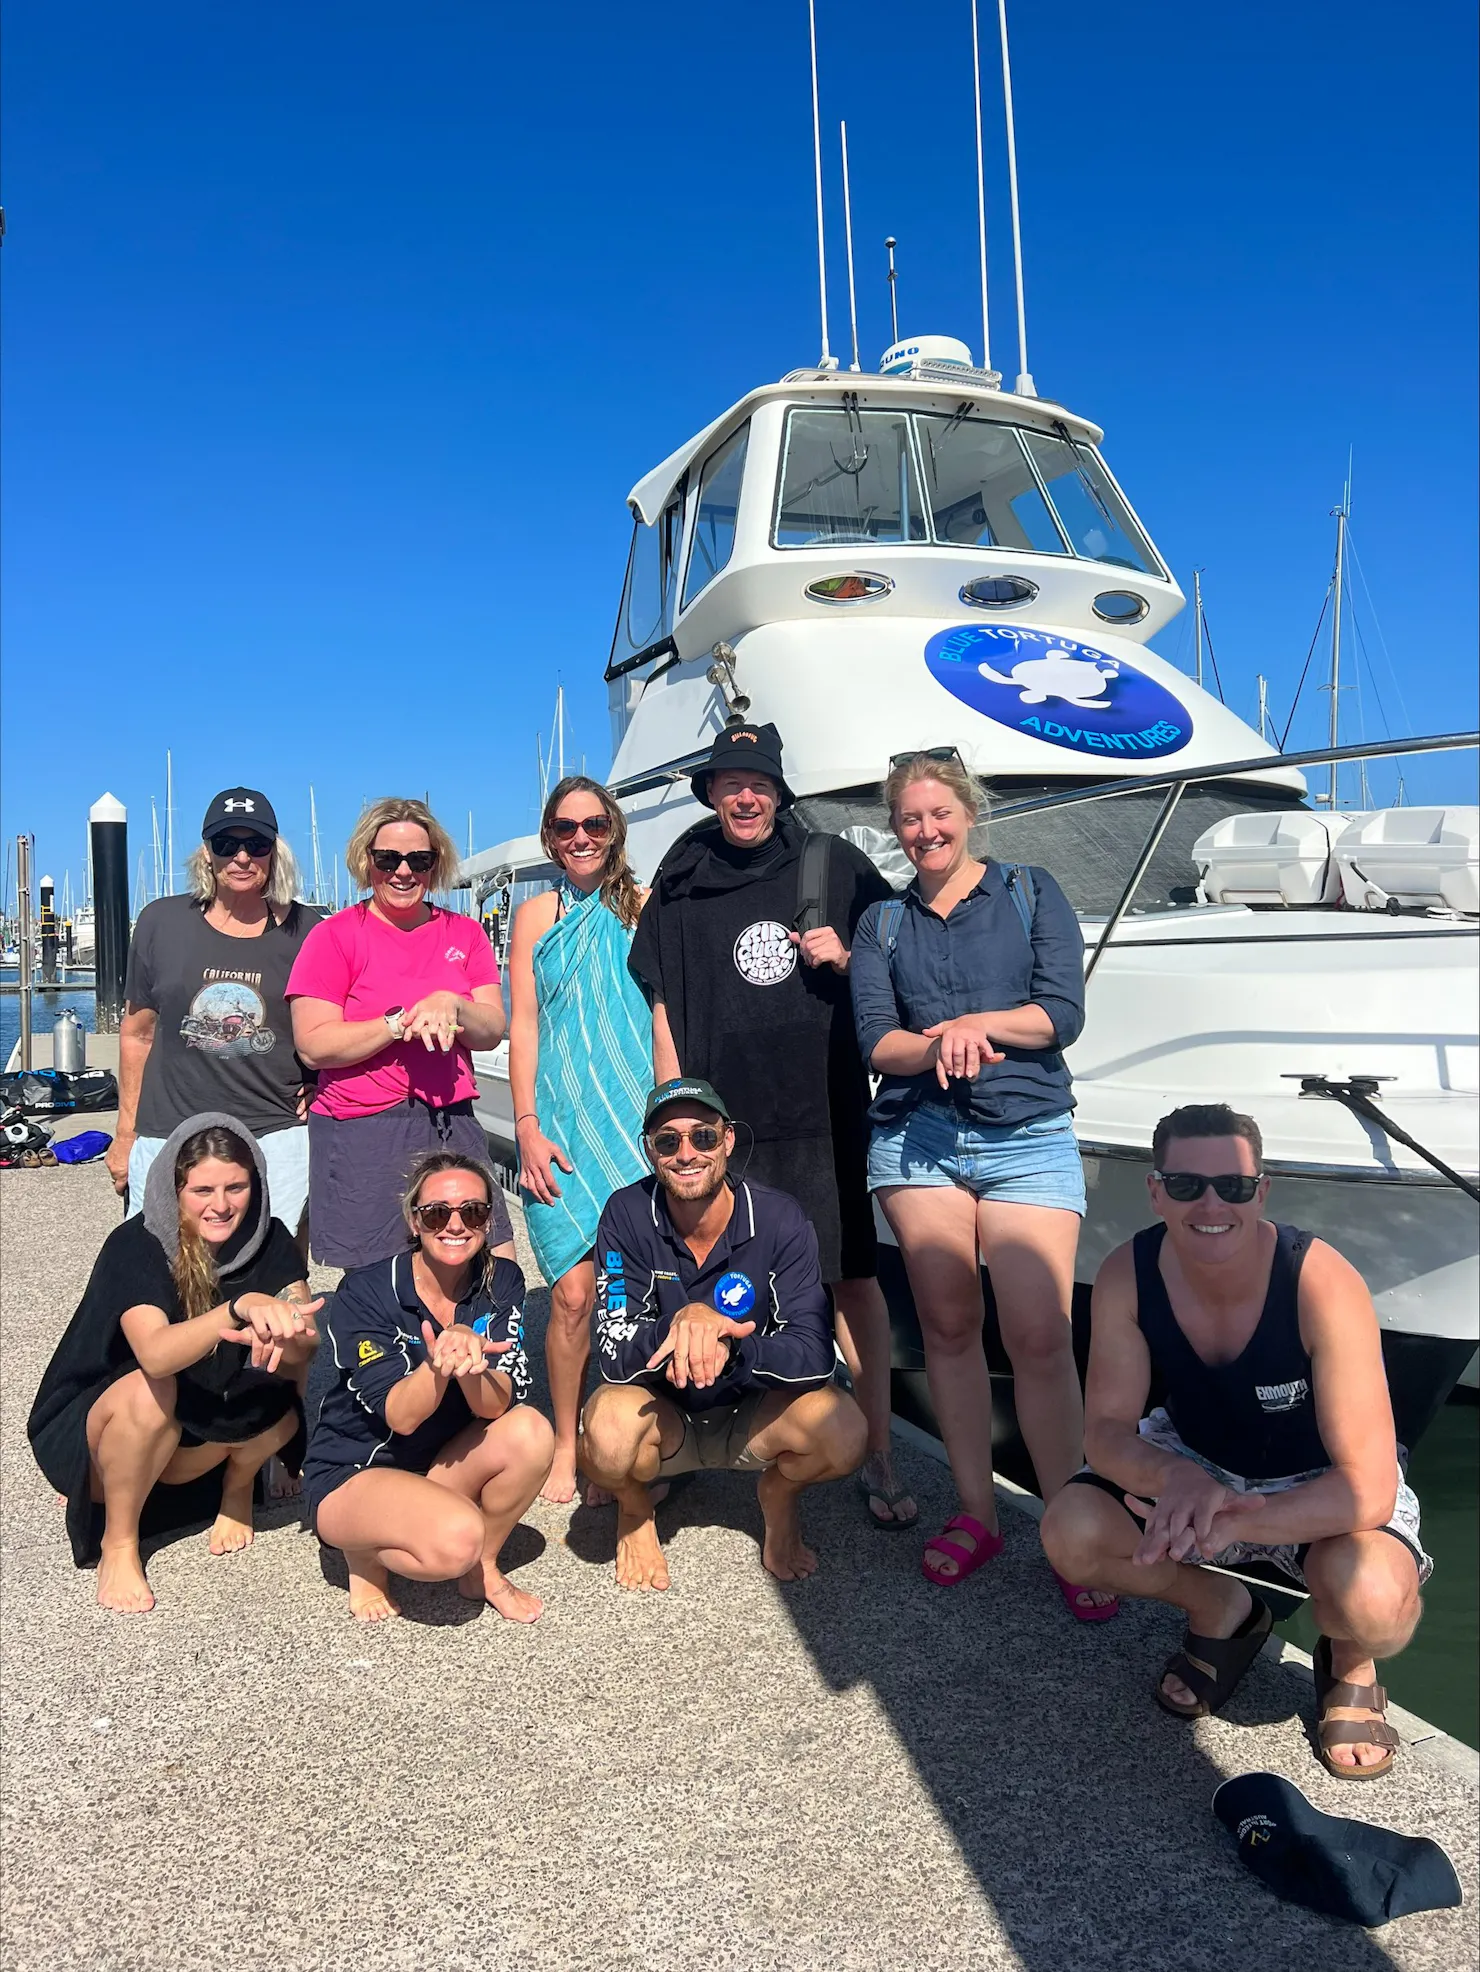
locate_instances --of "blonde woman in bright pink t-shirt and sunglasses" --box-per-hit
[286,797,514,1266]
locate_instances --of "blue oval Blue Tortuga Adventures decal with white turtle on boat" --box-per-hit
[924,623,1192,759]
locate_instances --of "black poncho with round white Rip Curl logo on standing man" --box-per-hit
[629,812,893,1282]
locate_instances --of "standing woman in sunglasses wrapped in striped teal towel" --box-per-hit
[508,775,652,1503]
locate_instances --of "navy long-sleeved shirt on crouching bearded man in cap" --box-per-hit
[595,1177,836,1410]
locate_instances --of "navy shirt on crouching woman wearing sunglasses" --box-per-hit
[303,1252,530,1493]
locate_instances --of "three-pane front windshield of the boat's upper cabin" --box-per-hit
[771,410,1163,576]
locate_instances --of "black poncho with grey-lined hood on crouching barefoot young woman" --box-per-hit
[26,1112,305,1568]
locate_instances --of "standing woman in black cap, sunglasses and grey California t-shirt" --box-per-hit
[106,787,321,1234]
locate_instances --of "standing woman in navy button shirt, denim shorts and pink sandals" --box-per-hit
[851,749,1115,1621]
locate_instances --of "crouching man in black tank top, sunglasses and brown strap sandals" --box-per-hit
[1043,1102,1433,1781]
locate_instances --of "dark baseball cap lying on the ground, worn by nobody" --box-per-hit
[1212,1773,1464,1929]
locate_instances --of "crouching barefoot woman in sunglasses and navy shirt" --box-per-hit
[303,1152,554,1623]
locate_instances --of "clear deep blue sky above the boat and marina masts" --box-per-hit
[0,0,1476,903]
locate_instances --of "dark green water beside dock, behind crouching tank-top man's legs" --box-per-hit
[1279,1398,1480,1745]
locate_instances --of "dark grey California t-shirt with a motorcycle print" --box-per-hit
[124,897,323,1136]
